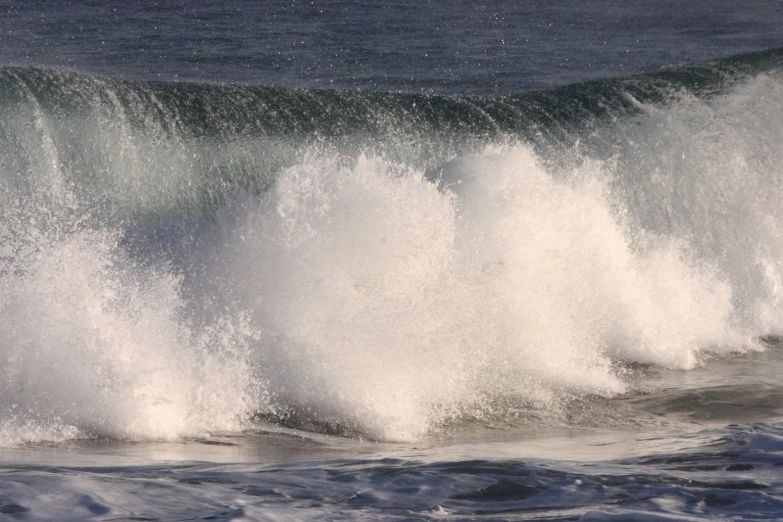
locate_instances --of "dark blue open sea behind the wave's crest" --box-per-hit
[6,0,783,94]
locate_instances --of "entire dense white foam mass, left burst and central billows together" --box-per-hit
[0,139,776,441]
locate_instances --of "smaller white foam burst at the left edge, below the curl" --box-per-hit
[0,231,259,444]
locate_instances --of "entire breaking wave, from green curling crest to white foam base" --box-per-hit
[0,50,783,444]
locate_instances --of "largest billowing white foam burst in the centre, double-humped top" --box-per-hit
[205,146,756,439]
